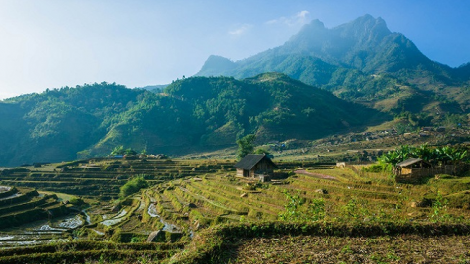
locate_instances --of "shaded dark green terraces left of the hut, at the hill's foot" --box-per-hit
[0,159,232,200]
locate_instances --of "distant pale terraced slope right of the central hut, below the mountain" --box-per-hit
[267,126,470,163]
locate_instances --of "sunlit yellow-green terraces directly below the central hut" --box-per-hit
[144,166,469,229]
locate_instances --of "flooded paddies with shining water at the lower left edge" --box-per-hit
[0,214,85,248]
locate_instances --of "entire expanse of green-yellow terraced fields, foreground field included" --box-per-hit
[0,159,470,263]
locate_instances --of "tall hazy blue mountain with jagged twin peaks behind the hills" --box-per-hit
[196,15,470,114]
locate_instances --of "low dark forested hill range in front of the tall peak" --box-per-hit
[0,73,387,166]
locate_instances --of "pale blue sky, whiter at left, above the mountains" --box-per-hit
[0,0,470,99]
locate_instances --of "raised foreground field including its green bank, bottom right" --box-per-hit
[172,222,470,263]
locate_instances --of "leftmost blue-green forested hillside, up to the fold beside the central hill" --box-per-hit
[0,83,142,165]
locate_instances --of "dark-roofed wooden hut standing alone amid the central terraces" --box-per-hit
[235,154,277,179]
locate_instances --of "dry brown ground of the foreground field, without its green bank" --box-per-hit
[225,235,470,263]
